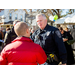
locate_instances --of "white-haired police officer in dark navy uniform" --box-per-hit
[31,14,67,65]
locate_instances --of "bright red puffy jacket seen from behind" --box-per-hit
[0,37,47,65]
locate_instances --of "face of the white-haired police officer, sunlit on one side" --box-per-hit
[36,16,47,30]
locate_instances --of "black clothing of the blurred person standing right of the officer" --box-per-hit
[62,31,74,65]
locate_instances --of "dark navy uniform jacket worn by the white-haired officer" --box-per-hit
[31,25,67,63]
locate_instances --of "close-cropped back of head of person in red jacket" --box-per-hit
[14,22,28,36]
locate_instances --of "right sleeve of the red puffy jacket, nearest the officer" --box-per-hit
[36,45,47,65]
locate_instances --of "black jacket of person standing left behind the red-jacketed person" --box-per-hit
[4,27,17,46]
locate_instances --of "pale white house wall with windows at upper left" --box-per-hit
[0,9,26,24]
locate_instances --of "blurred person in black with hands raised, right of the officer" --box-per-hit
[59,27,74,65]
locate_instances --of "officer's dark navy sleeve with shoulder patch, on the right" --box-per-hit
[53,30,67,64]
